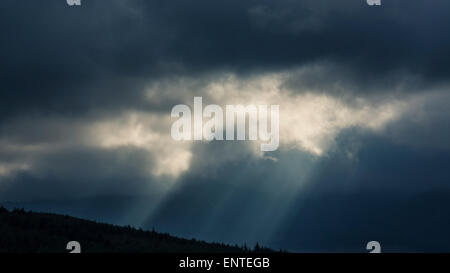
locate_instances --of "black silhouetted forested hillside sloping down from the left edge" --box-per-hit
[0,207,268,253]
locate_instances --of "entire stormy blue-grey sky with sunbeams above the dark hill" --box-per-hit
[0,0,450,252]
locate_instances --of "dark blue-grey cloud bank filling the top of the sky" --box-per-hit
[0,0,450,117]
